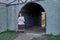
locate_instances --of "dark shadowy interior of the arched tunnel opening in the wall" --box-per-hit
[19,2,45,30]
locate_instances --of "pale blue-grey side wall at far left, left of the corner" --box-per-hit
[0,4,7,32]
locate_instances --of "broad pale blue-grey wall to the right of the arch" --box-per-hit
[39,0,60,35]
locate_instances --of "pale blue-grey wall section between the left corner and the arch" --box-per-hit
[8,5,23,30]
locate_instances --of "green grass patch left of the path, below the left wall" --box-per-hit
[0,31,18,40]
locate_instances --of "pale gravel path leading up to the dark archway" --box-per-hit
[14,33,46,40]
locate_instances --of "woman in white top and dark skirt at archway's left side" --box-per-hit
[18,13,25,32]
